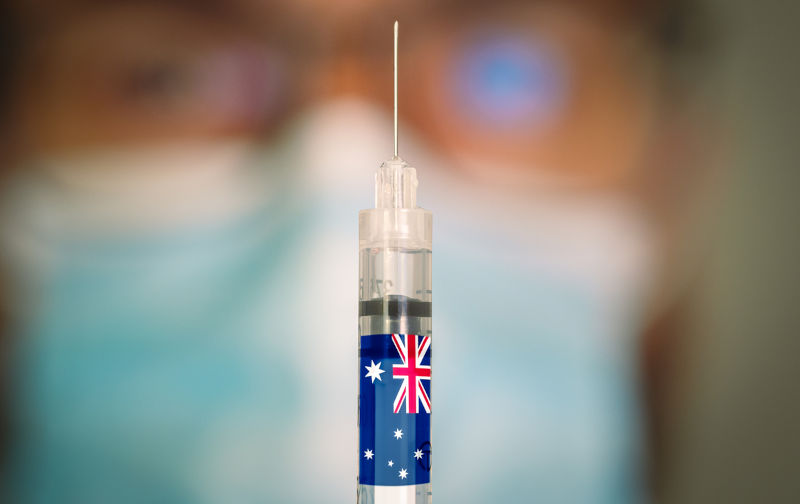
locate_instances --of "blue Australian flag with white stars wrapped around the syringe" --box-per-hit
[359,334,431,486]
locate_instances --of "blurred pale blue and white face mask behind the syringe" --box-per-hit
[6,103,660,504]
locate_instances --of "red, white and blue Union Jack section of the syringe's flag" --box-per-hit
[392,334,431,413]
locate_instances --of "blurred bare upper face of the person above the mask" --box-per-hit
[12,0,664,192]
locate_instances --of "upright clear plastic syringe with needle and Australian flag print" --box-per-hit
[357,21,433,504]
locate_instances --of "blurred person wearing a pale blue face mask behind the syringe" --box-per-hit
[2,0,712,503]
